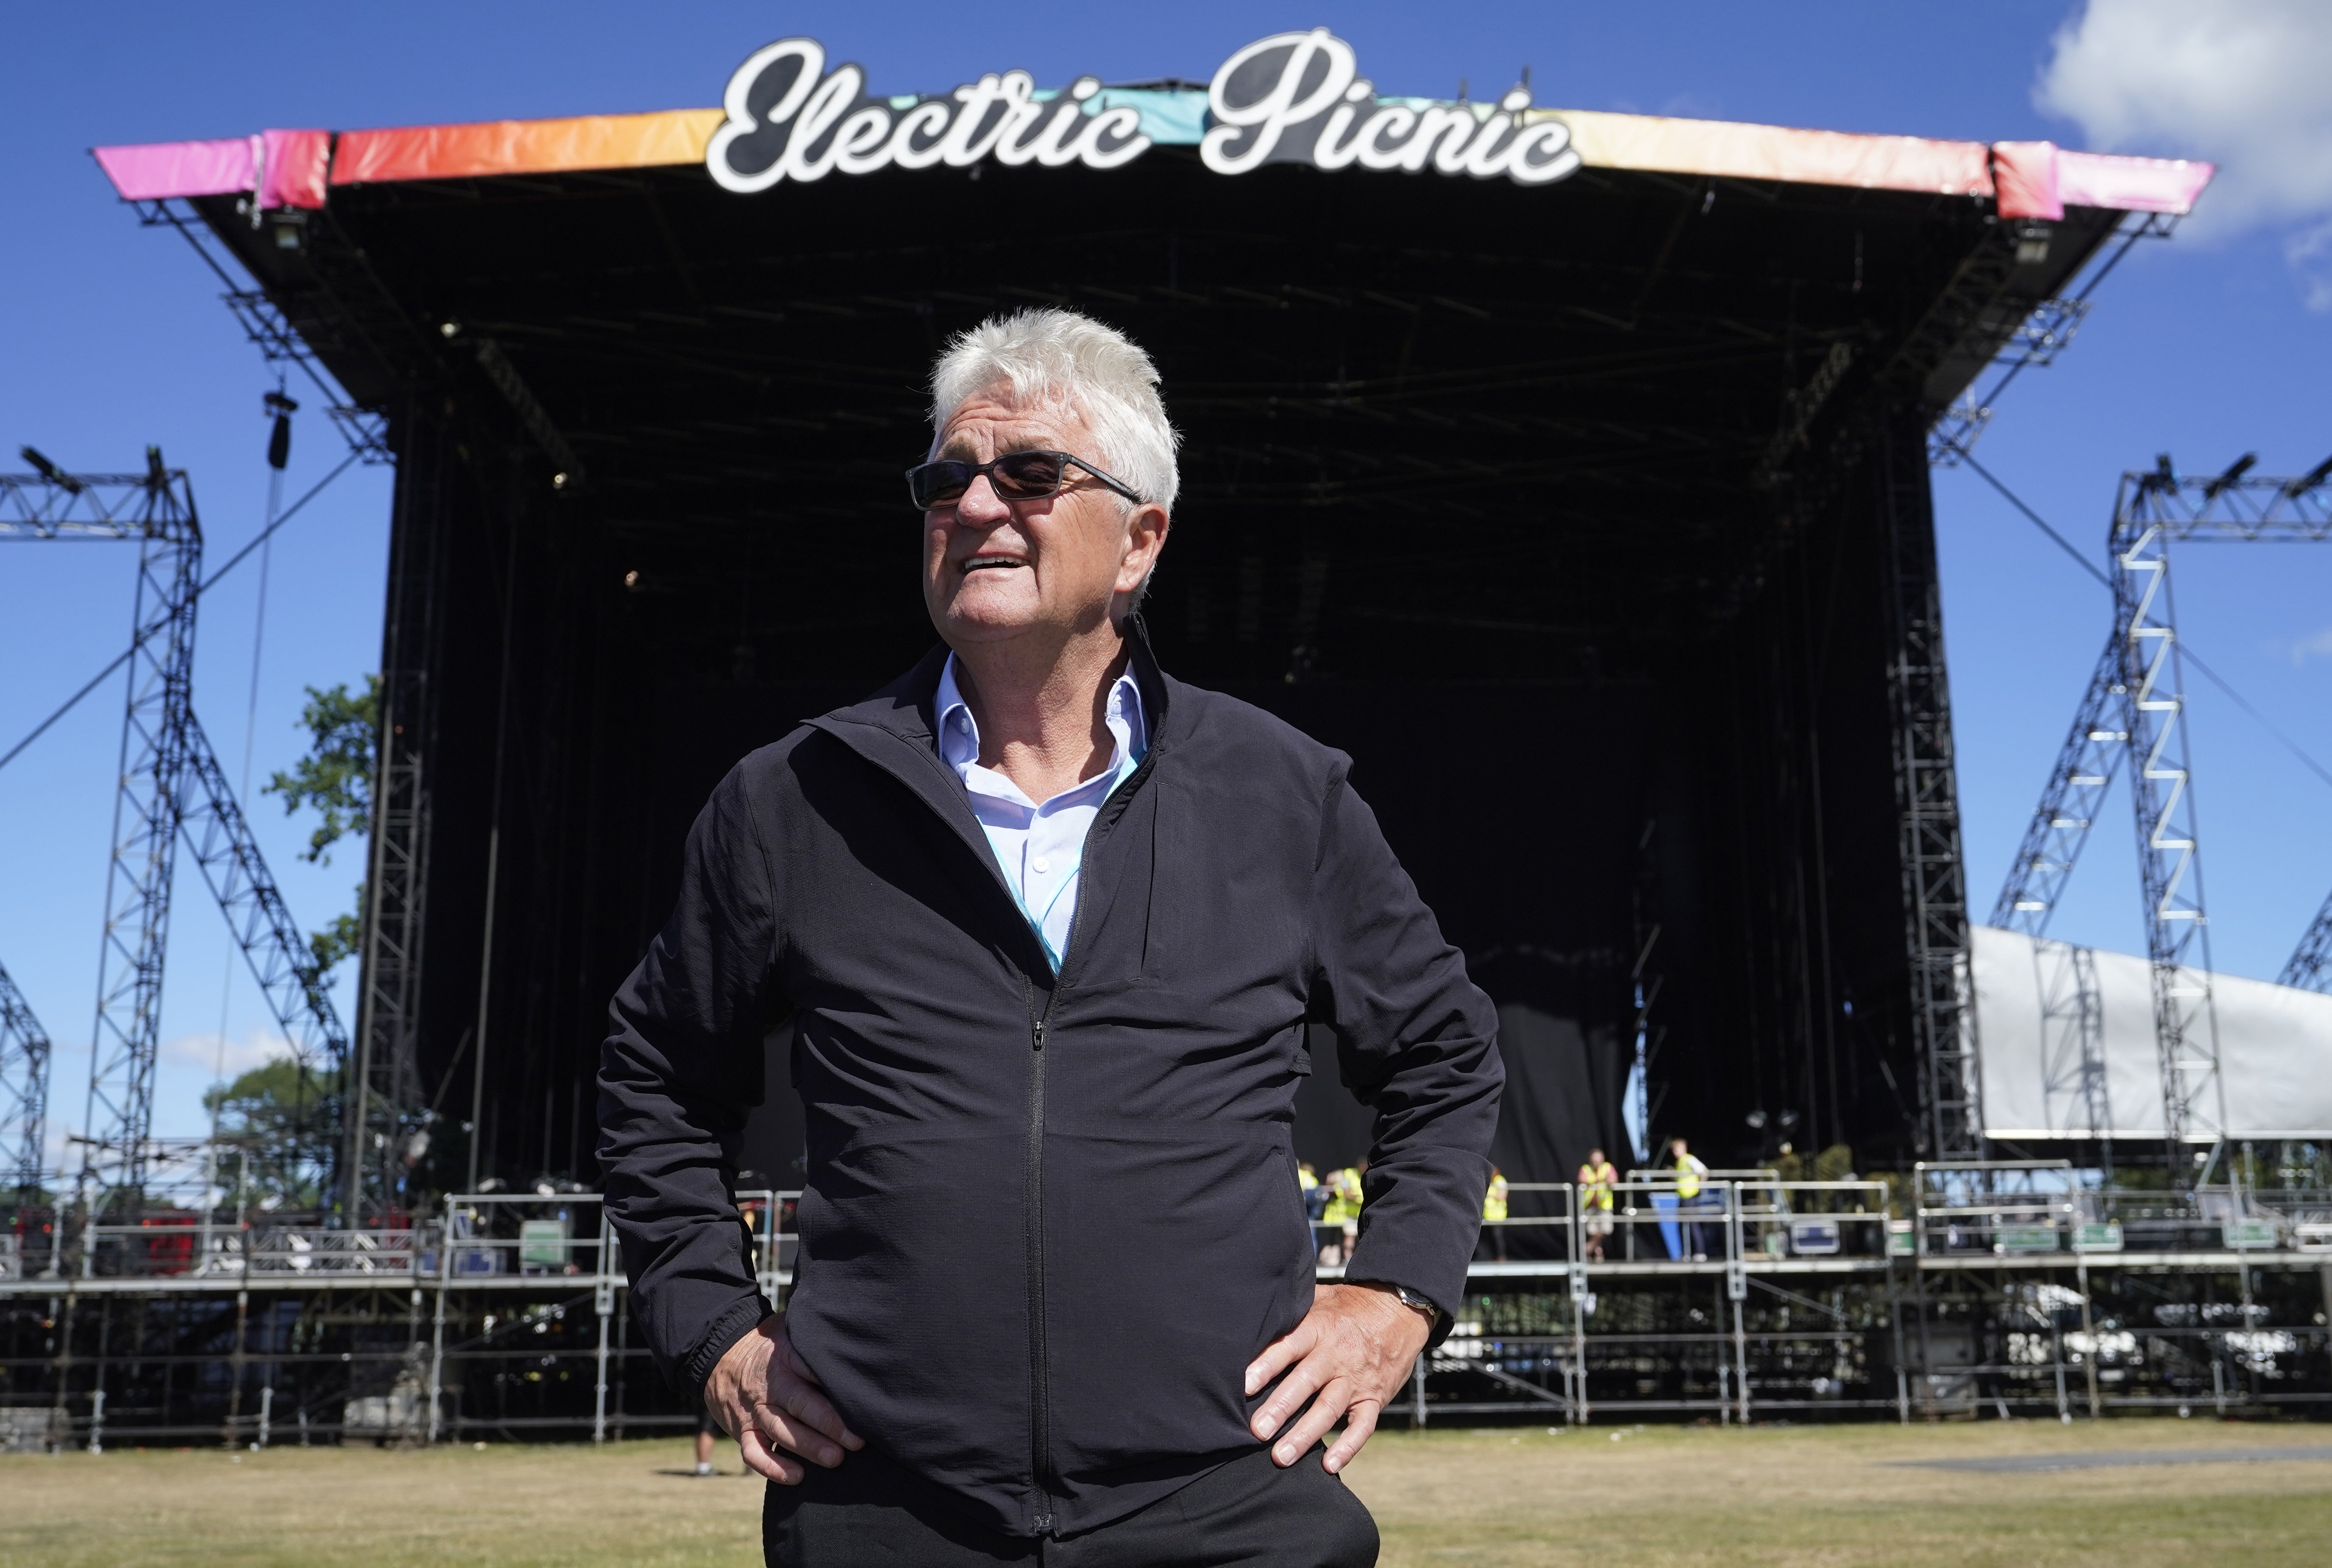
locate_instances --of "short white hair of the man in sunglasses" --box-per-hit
[930,310,1182,510]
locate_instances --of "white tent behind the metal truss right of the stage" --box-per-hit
[1971,925,2332,1139]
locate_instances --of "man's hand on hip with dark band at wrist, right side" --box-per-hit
[1248,1284,1432,1475]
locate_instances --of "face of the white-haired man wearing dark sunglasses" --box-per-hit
[924,387,1166,648]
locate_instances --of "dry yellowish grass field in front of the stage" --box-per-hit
[0,1421,2332,1568]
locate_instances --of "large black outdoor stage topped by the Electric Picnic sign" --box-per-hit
[9,35,2321,1453]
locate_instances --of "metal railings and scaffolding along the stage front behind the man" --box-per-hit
[0,1163,2332,1445]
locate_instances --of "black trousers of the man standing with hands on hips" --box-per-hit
[760,1447,1376,1568]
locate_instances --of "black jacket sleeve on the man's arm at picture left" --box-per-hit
[599,766,777,1393]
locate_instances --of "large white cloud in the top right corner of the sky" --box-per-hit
[2033,0,2332,244]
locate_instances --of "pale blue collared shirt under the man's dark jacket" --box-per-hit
[933,655,1150,972]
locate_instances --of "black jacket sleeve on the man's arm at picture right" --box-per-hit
[1313,771,1506,1333]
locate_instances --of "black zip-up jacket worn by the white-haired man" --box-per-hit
[599,629,1504,1535]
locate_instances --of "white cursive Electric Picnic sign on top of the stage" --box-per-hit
[704,28,1579,193]
